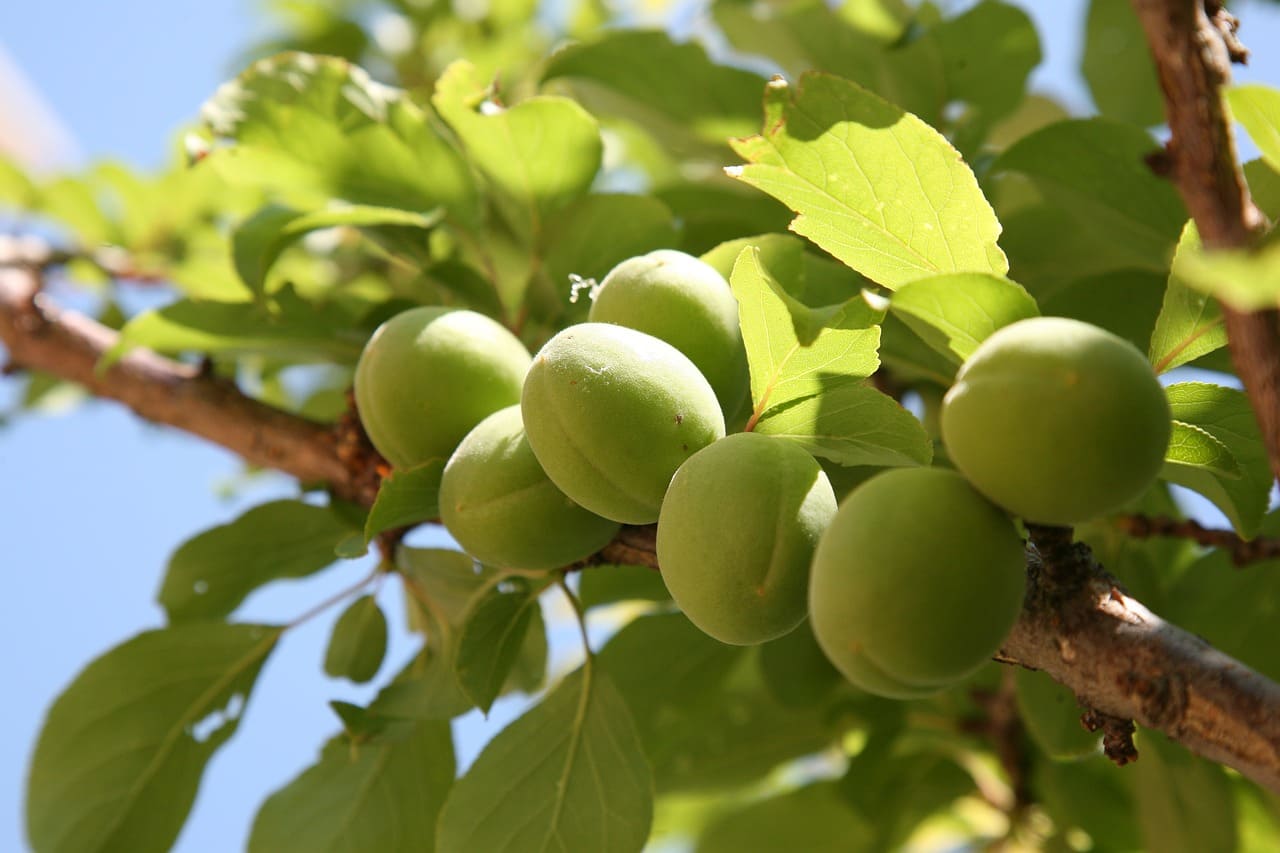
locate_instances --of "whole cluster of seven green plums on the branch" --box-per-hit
[356,250,1170,698]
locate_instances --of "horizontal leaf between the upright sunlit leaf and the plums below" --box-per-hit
[755,384,933,465]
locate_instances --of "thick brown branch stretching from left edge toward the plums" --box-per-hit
[0,266,378,505]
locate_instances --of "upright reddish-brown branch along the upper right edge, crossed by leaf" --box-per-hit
[1133,0,1280,476]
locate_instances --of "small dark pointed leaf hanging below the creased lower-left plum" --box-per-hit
[453,576,539,715]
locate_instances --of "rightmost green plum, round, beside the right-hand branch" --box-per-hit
[942,318,1171,525]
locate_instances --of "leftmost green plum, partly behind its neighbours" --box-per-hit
[356,306,531,467]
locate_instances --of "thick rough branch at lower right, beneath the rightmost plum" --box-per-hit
[996,528,1280,792]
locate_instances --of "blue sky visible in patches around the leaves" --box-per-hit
[0,0,1280,853]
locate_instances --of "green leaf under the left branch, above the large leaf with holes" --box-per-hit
[156,501,352,624]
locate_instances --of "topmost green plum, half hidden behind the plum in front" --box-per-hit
[588,248,749,418]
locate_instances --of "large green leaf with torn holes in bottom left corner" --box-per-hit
[27,621,280,853]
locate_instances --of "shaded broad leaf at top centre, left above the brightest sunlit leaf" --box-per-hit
[543,29,764,145]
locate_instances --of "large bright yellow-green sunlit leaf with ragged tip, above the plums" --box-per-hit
[731,74,1009,288]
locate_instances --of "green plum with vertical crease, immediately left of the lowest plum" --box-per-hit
[658,433,836,646]
